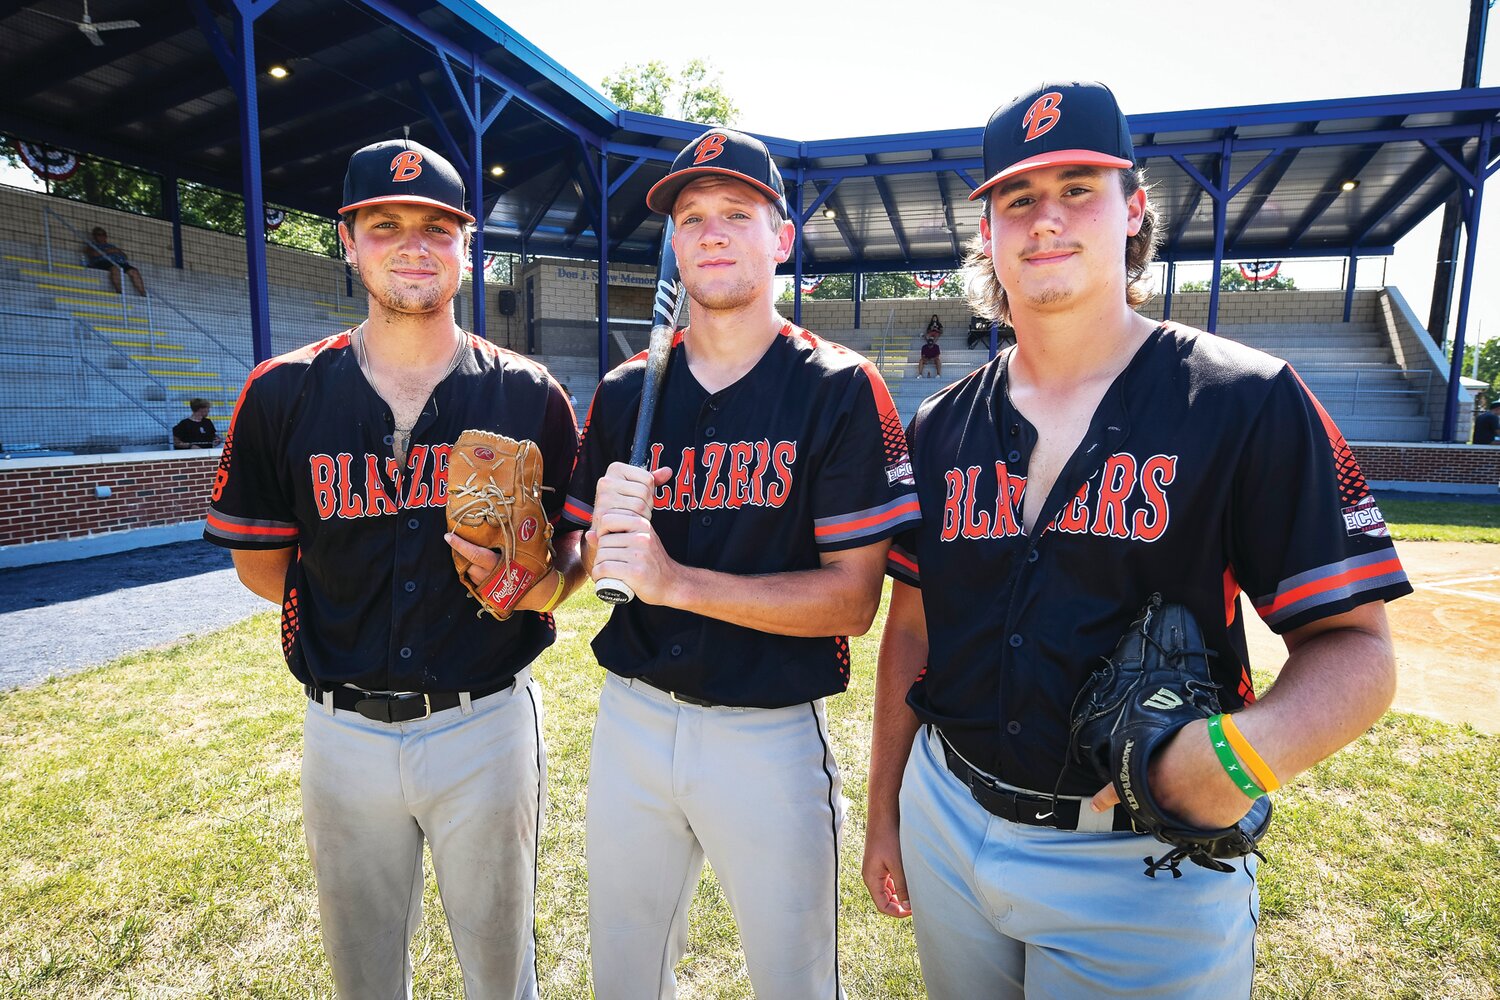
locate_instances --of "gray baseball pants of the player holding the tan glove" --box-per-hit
[302,670,548,1000]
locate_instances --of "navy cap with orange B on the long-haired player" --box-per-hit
[969,81,1136,201]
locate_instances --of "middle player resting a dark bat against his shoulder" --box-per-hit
[564,129,917,1000]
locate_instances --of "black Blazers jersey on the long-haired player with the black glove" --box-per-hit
[888,325,1412,795]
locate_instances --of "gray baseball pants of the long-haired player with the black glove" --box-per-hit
[902,726,1260,1000]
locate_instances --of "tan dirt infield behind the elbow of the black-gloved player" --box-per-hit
[1245,541,1500,733]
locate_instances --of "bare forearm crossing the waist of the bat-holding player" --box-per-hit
[665,564,881,636]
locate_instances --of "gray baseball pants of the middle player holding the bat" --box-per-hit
[587,673,848,1000]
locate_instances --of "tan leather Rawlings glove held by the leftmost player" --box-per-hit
[447,430,552,621]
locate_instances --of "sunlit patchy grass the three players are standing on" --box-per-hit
[0,597,1500,1000]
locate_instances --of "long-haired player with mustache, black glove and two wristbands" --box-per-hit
[864,82,1410,1000]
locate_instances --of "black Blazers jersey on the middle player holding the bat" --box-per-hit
[563,324,918,708]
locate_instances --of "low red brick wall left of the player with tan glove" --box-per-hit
[0,451,219,546]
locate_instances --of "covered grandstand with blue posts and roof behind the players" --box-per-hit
[0,0,1500,563]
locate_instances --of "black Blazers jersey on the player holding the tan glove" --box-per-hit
[204,331,578,693]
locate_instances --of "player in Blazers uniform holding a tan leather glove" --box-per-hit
[204,139,582,1000]
